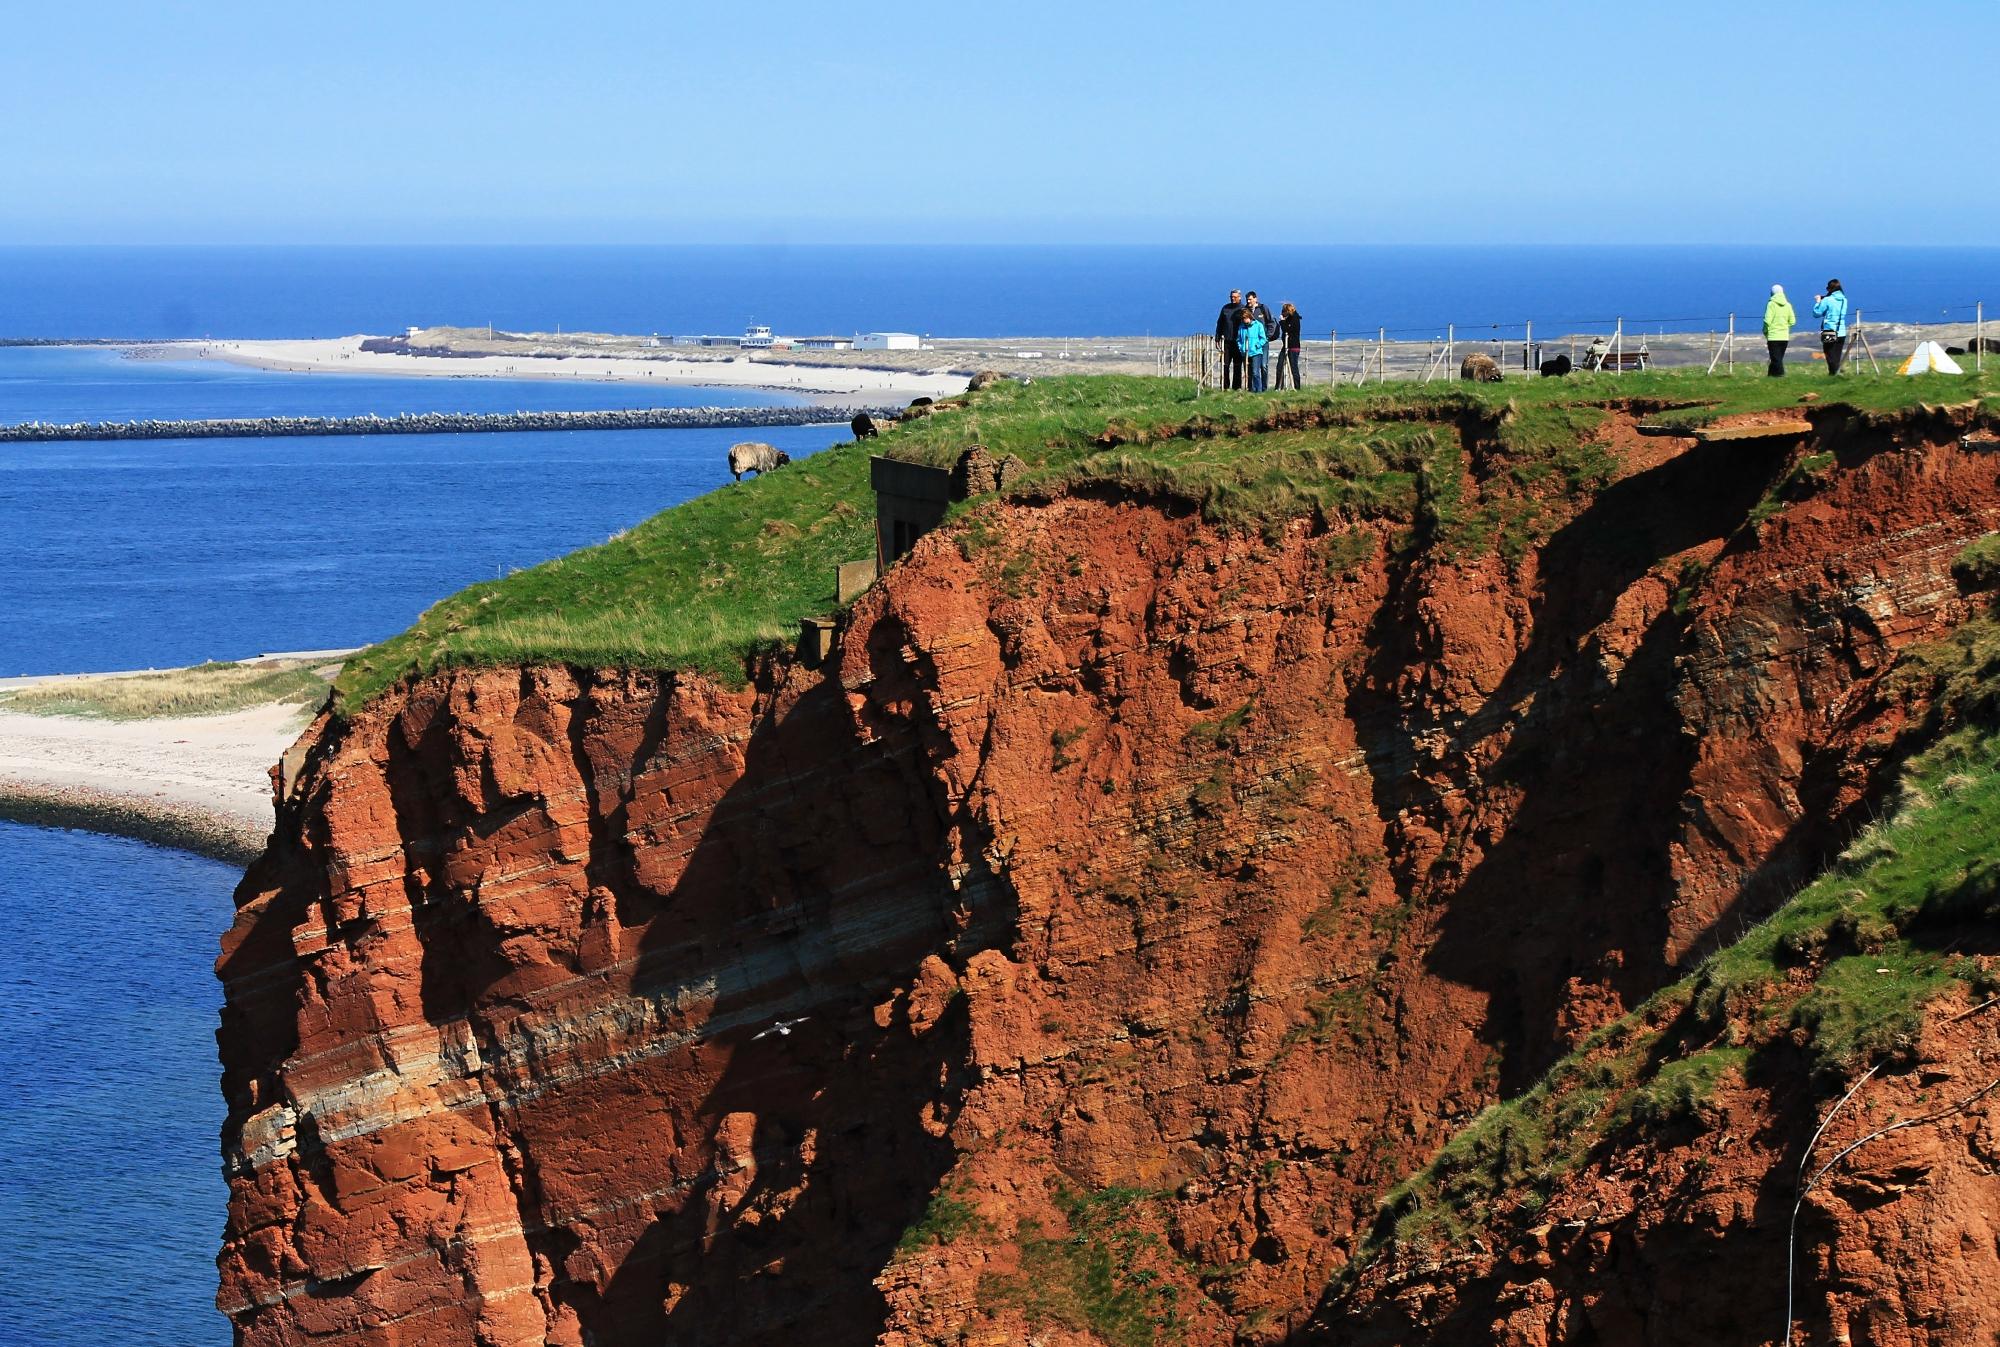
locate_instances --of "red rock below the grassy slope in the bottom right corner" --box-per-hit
[1302,995,2000,1347]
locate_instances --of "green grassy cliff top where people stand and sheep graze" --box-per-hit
[336,362,2000,713]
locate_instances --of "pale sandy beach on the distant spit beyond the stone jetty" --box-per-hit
[180,336,966,404]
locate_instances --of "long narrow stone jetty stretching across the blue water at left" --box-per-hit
[0,406,898,444]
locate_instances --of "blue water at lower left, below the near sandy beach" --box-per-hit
[0,823,236,1347]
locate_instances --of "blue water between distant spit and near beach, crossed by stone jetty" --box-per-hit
[0,348,846,677]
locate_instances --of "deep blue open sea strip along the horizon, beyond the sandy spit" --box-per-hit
[0,244,2000,338]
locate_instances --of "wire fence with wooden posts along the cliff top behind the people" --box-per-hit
[1184,300,2000,388]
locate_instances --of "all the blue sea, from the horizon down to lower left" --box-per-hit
[0,246,2000,1347]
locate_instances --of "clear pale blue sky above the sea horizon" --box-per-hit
[0,0,2000,244]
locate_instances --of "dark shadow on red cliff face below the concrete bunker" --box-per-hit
[554,622,1014,1347]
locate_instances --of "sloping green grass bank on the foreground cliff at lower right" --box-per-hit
[1350,616,2000,1275]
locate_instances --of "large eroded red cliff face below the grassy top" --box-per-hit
[220,409,2000,1347]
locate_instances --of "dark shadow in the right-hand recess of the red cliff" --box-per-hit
[1350,433,1786,1093]
